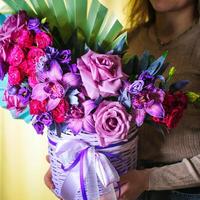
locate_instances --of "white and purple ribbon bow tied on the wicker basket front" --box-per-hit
[55,139,120,200]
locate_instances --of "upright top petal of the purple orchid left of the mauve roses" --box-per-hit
[48,60,63,81]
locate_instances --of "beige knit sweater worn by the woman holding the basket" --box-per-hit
[129,25,200,190]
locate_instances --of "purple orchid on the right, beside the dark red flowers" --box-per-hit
[132,85,165,126]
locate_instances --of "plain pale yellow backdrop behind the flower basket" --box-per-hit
[0,0,128,200]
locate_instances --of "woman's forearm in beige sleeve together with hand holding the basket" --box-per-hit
[119,154,200,200]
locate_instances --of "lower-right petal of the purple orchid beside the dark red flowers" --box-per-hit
[145,103,165,118]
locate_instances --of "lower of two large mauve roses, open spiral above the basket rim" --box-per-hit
[94,101,132,146]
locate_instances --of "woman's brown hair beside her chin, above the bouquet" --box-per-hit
[127,0,200,28]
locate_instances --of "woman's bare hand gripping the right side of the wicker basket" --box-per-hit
[119,169,151,200]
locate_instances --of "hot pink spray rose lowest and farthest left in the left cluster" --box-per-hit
[8,66,23,85]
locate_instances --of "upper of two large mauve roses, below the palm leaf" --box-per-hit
[77,51,124,99]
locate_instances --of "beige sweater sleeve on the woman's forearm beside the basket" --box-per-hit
[149,154,200,190]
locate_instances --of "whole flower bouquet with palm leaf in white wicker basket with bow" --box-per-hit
[0,0,200,200]
